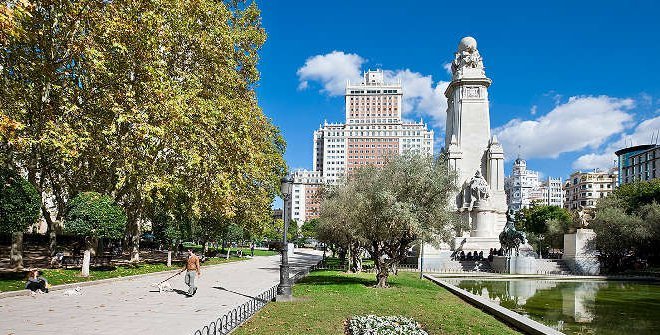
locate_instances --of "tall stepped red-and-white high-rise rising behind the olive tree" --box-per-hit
[313,70,433,184]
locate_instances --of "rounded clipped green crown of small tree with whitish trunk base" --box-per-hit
[64,192,126,238]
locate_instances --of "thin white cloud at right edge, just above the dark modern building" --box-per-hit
[572,116,660,170]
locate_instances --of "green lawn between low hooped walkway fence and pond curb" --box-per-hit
[234,271,520,335]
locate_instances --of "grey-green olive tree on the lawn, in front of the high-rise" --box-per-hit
[318,153,457,287]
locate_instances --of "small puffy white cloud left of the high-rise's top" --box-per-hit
[297,51,365,96]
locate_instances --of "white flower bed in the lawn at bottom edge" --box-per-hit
[346,315,428,335]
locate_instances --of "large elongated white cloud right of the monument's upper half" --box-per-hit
[494,96,634,160]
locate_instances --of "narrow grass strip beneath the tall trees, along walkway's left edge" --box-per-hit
[0,257,245,292]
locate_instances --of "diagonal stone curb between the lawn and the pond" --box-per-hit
[424,275,564,335]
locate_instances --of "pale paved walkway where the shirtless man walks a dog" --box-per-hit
[0,250,321,335]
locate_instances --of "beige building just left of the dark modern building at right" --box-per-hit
[564,169,618,211]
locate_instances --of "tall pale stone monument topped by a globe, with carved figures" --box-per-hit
[445,37,507,252]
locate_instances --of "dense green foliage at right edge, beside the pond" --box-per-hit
[589,179,660,271]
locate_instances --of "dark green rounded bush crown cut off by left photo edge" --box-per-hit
[0,167,41,234]
